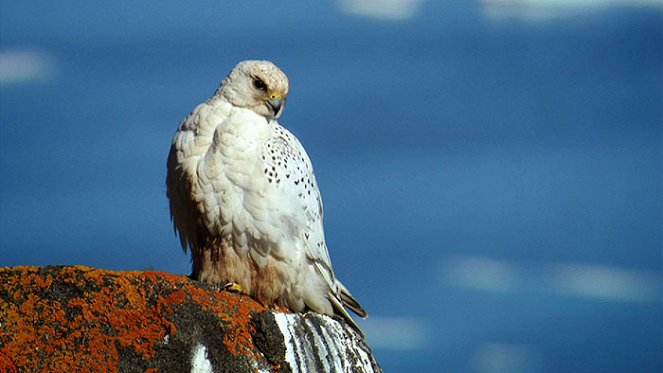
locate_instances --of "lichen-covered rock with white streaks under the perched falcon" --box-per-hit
[0,266,381,372]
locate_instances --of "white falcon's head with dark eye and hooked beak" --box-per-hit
[217,61,290,120]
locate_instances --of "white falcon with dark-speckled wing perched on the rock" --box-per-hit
[166,60,367,335]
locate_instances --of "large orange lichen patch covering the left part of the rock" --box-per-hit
[0,266,276,372]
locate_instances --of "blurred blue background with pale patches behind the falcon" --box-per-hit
[0,0,663,372]
